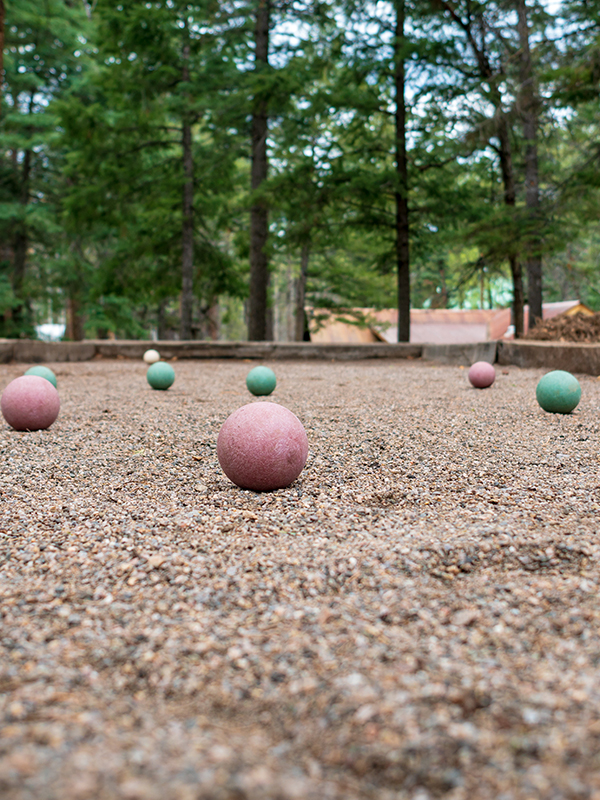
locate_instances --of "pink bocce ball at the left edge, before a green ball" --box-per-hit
[0,375,60,431]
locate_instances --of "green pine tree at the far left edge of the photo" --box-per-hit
[0,0,85,335]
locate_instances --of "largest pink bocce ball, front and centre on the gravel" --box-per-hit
[217,402,308,492]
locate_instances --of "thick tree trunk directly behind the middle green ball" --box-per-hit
[248,0,271,341]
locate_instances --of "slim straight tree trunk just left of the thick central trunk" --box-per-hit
[179,35,194,339]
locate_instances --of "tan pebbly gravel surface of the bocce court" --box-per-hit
[0,360,600,800]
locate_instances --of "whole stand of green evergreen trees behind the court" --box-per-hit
[0,0,600,341]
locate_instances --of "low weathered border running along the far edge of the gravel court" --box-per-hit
[0,339,600,375]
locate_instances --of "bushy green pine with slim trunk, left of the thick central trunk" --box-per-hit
[62,2,239,338]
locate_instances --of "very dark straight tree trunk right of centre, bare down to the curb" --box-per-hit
[394,0,410,342]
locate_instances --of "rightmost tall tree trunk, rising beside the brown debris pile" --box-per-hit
[516,0,542,327]
